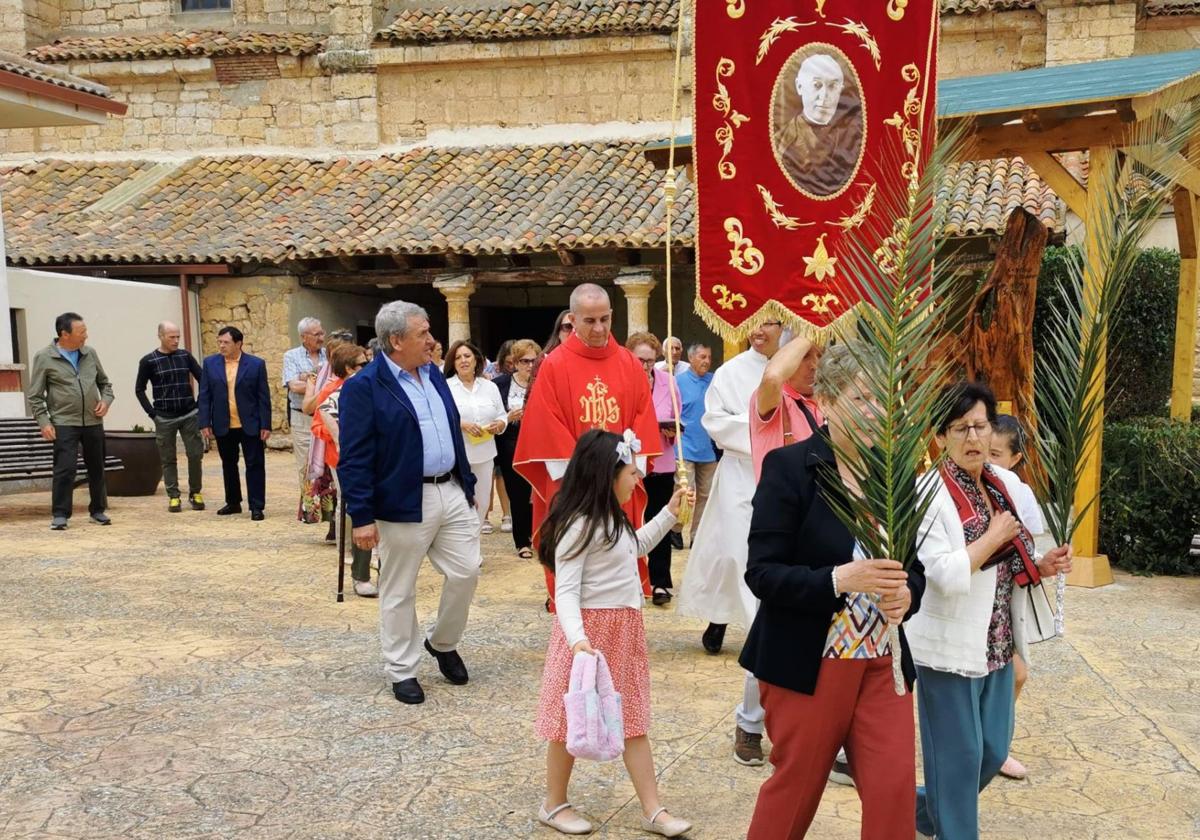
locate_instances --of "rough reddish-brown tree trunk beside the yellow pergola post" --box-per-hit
[965,208,1049,469]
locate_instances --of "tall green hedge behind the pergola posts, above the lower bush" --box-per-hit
[1033,246,1180,420]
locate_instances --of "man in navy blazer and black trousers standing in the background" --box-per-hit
[197,326,271,521]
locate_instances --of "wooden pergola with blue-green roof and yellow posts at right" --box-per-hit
[646,49,1200,587]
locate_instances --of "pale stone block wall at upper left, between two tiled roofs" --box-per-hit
[0,55,379,155]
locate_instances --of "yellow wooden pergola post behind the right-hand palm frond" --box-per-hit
[1067,146,1117,587]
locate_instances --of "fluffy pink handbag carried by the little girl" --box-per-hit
[563,650,625,761]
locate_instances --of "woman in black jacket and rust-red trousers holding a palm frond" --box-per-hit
[740,346,925,840]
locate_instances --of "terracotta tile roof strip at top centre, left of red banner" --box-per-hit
[376,0,679,43]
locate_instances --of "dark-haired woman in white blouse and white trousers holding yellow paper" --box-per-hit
[444,341,509,525]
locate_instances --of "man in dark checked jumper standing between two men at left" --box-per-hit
[133,320,204,514]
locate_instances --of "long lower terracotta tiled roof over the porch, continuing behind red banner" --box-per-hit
[0,142,1062,264]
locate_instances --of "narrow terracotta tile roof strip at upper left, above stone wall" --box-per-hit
[29,30,324,61]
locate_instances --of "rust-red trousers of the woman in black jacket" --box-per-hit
[748,656,917,840]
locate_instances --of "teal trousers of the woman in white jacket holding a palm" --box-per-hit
[917,662,1014,840]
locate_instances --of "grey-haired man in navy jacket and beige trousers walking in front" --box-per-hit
[337,300,480,703]
